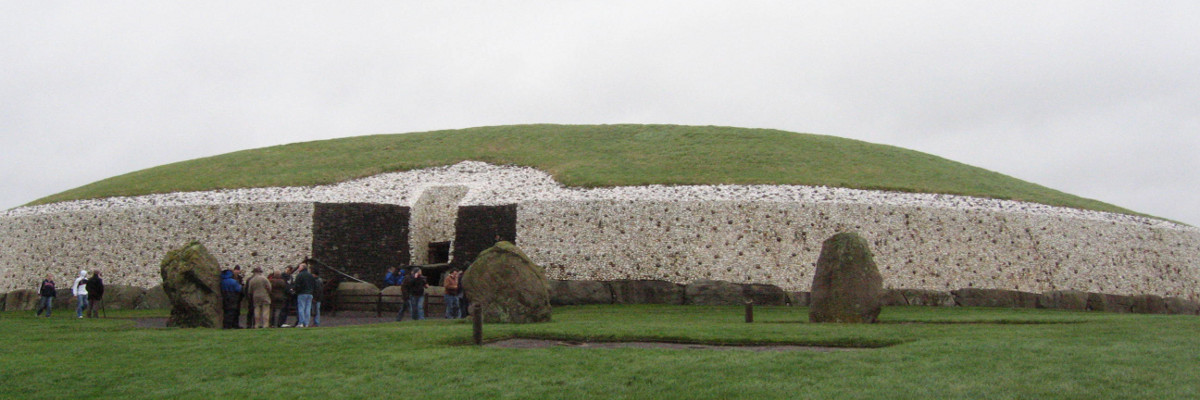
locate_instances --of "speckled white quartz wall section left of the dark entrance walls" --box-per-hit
[0,203,313,292]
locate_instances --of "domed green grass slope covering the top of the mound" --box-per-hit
[30,125,1135,214]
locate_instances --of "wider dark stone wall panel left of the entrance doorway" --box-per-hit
[312,203,409,285]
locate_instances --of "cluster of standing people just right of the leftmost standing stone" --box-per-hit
[221,258,325,329]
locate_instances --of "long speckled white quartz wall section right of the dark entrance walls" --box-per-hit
[517,201,1200,300]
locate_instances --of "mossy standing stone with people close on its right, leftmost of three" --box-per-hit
[160,241,222,328]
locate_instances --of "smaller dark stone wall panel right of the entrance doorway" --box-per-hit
[450,204,517,268]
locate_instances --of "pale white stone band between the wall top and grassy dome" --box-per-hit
[7,161,1200,232]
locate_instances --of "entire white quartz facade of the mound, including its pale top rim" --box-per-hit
[0,162,1200,300]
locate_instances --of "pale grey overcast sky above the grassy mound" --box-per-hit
[0,0,1200,225]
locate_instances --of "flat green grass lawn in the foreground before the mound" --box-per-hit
[0,305,1200,399]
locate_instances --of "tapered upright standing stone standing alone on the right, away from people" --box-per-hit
[809,233,883,323]
